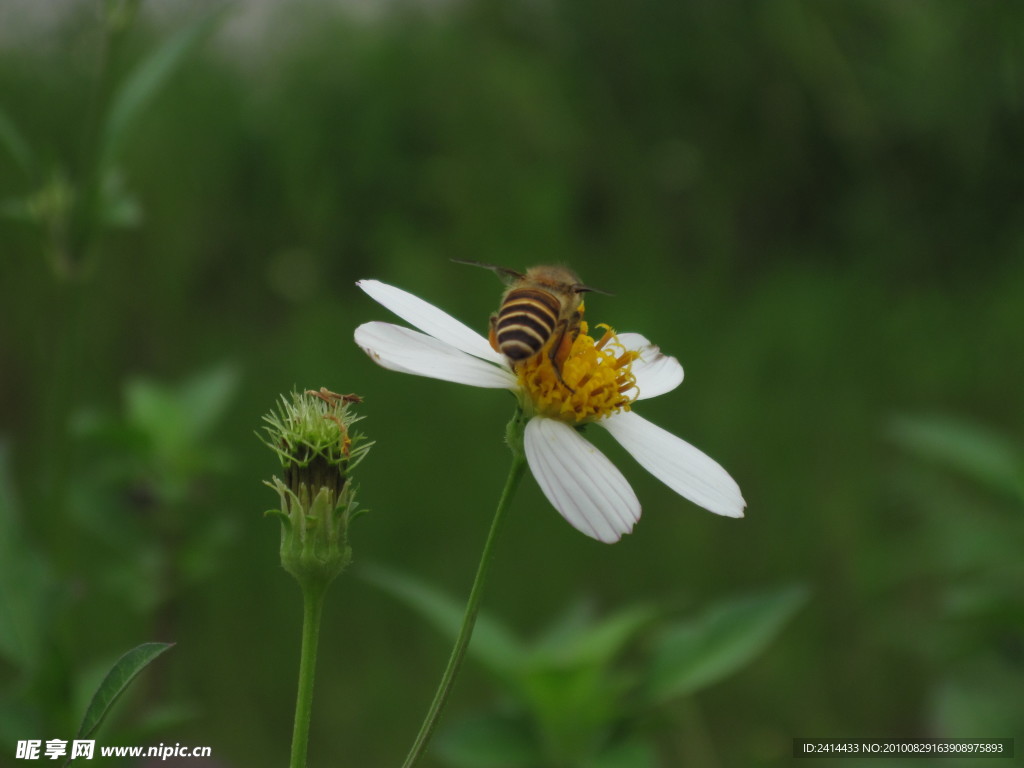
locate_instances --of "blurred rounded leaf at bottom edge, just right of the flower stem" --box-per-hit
[436,715,544,768]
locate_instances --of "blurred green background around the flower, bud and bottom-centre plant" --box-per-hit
[0,0,1024,768]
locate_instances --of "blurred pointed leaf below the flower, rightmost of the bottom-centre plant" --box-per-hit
[647,586,807,702]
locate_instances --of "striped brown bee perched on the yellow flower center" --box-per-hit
[453,259,605,390]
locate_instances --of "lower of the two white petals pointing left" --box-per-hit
[355,323,516,389]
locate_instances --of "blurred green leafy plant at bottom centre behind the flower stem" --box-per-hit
[362,566,806,768]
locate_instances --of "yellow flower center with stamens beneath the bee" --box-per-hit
[515,323,639,424]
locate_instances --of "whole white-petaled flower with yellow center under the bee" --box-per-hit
[355,280,746,543]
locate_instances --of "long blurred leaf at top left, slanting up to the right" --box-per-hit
[99,5,228,172]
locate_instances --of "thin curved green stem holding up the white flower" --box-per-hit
[401,421,526,768]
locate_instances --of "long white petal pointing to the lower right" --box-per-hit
[597,411,746,517]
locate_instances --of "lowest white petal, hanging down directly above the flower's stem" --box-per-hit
[523,418,640,544]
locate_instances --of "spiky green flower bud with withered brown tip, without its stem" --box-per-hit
[260,388,373,588]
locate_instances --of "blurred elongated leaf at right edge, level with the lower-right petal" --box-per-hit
[889,416,1024,498]
